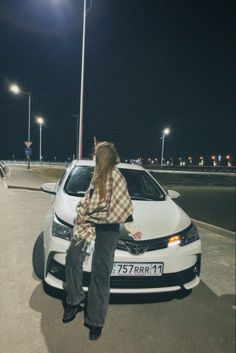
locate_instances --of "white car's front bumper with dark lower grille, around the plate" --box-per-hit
[45,238,201,294]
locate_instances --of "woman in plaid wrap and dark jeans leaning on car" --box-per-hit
[63,142,142,340]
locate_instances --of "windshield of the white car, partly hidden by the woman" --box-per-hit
[64,166,165,201]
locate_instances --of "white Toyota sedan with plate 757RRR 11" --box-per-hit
[33,160,201,294]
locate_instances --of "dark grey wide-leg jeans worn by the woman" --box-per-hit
[65,227,119,327]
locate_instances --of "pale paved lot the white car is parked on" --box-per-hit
[0,168,235,353]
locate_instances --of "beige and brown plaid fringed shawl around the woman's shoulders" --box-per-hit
[73,168,133,243]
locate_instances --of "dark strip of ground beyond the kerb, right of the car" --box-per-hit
[151,170,236,232]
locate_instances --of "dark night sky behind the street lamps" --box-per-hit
[0,0,236,160]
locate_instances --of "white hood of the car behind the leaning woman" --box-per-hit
[55,192,191,240]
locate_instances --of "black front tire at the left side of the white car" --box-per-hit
[32,232,44,279]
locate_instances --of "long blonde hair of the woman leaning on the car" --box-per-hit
[93,141,120,199]
